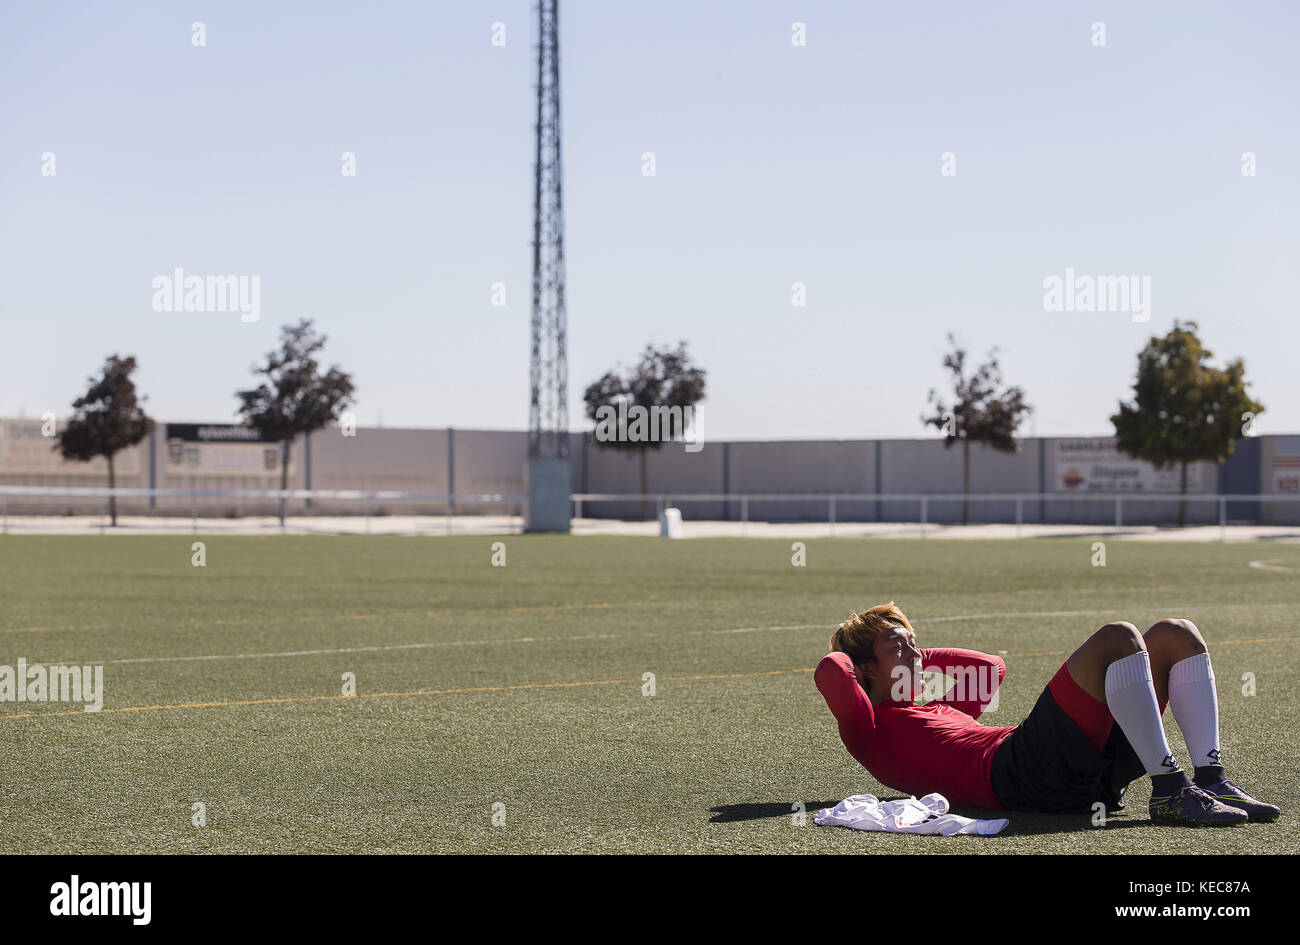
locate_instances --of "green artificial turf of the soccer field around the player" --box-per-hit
[0,536,1300,854]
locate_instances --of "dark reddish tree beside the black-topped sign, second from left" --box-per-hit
[235,318,356,526]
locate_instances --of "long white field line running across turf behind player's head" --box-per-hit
[50,602,1300,666]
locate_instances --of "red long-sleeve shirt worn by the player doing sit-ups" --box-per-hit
[814,647,1015,810]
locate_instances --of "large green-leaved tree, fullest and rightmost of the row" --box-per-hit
[1110,321,1264,526]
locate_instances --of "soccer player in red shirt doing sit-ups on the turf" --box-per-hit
[815,601,1279,825]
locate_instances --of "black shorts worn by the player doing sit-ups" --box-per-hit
[989,664,1147,814]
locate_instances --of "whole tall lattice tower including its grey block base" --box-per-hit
[524,0,569,532]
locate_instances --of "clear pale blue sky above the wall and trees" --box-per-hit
[0,0,1300,438]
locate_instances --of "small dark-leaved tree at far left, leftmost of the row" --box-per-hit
[55,355,153,528]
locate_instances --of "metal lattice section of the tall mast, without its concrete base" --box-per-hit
[528,0,568,459]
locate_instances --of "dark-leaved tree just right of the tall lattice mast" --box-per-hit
[582,342,705,519]
